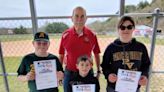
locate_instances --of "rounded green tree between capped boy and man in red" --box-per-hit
[45,22,69,33]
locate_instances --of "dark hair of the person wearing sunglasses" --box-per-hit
[117,16,135,29]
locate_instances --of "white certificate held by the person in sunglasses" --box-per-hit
[115,69,141,92]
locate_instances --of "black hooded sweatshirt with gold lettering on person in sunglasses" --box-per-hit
[101,38,150,89]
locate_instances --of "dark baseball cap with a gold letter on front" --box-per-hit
[34,32,49,41]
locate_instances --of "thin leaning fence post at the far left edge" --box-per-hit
[0,41,10,92]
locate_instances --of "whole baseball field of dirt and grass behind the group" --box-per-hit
[0,35,164,92]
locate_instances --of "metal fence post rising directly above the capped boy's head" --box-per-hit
[29,0,38,34]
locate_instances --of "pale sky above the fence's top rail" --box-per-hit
[0,0,152,17]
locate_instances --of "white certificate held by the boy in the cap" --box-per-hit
[34,59,58,90]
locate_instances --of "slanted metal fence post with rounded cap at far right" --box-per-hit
[146,8,160,92]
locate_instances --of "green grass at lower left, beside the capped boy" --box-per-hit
[0,57,27,92]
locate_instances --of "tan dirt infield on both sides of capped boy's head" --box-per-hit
[2,40,59,57]
